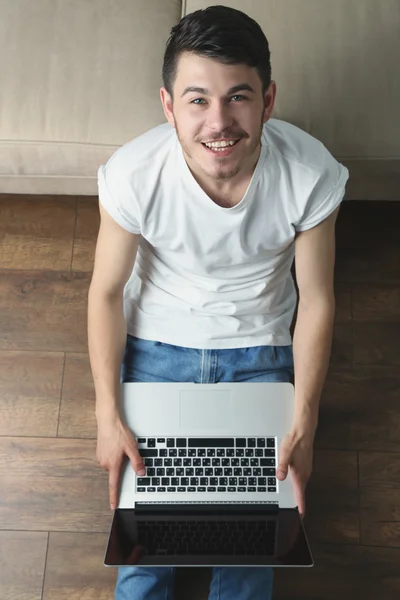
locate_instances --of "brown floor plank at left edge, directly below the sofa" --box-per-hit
[0,194,77,271]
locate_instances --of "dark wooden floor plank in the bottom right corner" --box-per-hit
[274,544,400,600]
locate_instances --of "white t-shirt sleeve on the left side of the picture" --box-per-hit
[97,165,140,235]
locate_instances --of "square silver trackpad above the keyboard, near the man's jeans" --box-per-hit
[180,390,232,429]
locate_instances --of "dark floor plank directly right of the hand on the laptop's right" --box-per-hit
[304,448,360,544]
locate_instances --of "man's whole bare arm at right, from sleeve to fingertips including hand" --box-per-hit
[277,207,339,517]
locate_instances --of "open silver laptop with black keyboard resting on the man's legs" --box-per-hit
[104,382,314,567]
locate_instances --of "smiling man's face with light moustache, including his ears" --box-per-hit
[160,52,276,182]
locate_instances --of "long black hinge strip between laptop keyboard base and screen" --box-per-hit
[135,502,279,515]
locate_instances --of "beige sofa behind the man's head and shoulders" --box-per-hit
[0,0,400,200]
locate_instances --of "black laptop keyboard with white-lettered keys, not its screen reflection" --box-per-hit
[136,437,277,493]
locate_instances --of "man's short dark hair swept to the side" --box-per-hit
[162,5,271,100]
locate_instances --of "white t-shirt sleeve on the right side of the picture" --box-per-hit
[293,148,349,231]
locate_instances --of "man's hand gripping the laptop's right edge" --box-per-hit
[277,431,314,518]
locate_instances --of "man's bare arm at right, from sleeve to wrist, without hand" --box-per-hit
[293,206,340,436]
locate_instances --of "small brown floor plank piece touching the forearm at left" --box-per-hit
[58,353,97,439]
